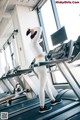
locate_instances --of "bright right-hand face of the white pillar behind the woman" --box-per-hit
[17,6,39,67]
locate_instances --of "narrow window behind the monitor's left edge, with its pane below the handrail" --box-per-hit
[41,0,67,83]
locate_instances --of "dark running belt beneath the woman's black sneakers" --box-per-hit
[9,100,72,120]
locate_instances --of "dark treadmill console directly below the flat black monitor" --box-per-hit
[47,40,73,59]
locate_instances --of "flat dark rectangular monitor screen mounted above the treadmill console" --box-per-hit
[51,26,67,45]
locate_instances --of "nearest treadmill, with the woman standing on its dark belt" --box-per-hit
[1,26,80,120]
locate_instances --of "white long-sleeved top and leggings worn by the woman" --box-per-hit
[31,27,55,106]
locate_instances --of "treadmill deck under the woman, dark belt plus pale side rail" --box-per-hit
[9,100,79,120]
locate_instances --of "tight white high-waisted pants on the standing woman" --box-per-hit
[34,58,55,106]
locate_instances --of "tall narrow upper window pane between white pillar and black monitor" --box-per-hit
[41,0,57,50]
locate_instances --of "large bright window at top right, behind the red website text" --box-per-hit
[55,0,80,40]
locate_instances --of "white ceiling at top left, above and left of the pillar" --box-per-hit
[0,0,44,48]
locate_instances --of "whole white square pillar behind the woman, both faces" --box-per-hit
[12,5,39,68]
